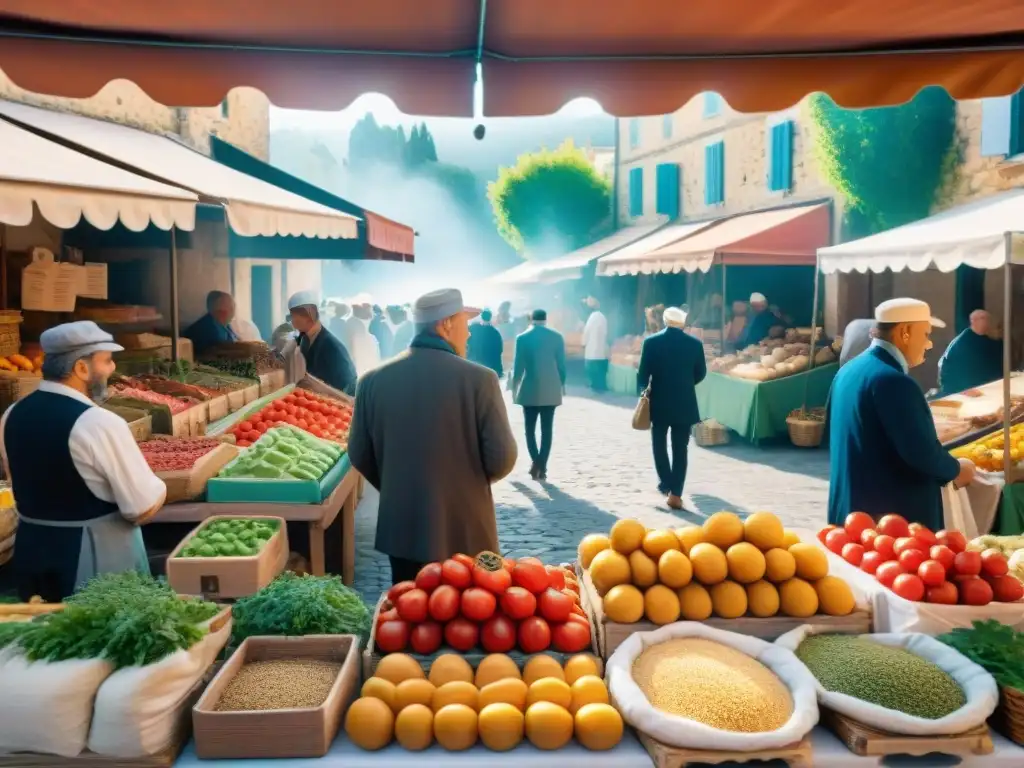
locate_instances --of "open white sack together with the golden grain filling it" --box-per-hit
[605,622,818,752]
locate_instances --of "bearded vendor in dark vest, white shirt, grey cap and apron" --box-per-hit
[0,321,167,602]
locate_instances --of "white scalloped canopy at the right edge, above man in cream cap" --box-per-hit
[818,189,1024,273]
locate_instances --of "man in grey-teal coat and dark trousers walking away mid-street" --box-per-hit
[511,309,565,480]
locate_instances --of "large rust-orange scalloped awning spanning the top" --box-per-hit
[0,0,1024,116]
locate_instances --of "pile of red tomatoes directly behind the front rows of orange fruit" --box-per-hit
[374,553,591,654]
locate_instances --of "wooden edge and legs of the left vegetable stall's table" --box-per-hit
[151,468,362,587]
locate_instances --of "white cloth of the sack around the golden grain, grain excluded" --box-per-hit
[605,622,818,752]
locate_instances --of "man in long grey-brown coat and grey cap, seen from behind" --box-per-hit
[348,289,517,584]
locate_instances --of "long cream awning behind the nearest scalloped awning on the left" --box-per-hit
[0,100,358,240]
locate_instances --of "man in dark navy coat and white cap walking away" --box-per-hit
[637,307,708,509]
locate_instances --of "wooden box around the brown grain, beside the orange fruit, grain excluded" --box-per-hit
[192,635,359,768]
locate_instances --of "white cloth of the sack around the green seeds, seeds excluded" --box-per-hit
[775,624,999,736]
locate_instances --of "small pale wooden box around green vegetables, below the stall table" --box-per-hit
[167,515,289,599]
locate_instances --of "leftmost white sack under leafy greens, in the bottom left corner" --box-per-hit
[0,645,114,758]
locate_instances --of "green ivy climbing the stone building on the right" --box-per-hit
[810,87,956,237]
